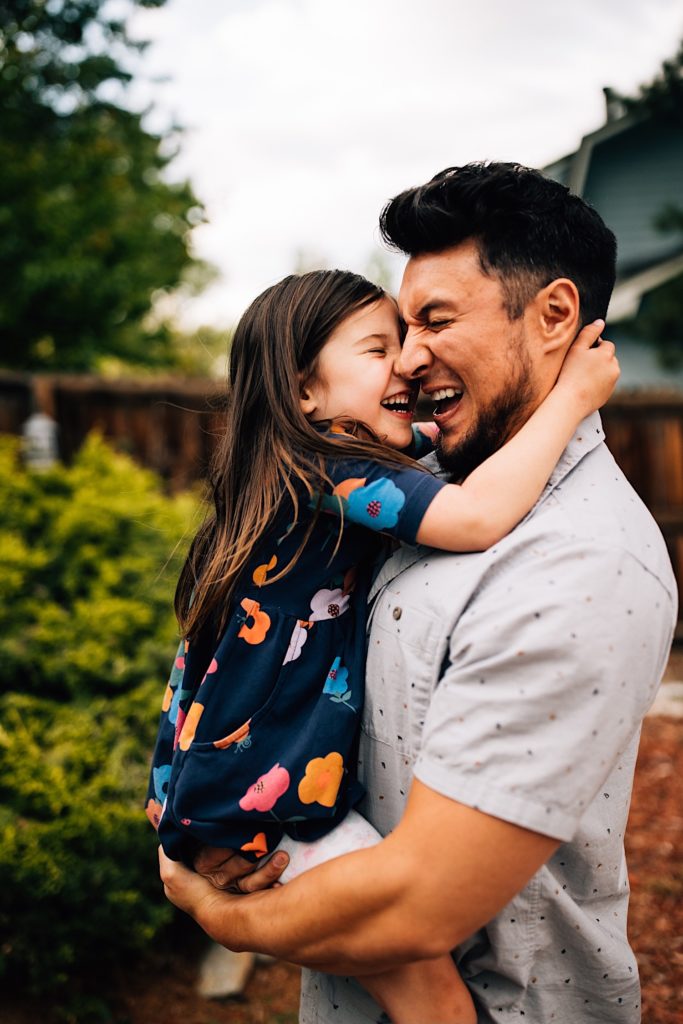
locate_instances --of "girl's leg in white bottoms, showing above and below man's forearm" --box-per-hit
[270,811,476,1024]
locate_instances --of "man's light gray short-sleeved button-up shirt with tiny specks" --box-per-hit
[300,414,677,1024]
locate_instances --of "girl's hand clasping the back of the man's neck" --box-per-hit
[555,319,621,418]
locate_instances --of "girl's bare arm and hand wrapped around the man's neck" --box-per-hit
[417,321,620,551]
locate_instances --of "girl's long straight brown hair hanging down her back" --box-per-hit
[175,270,423,639]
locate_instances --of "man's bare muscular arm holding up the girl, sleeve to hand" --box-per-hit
[162,780,558,976]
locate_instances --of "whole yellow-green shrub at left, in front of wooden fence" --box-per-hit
[0,437,196,992]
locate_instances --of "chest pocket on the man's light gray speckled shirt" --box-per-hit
[362,587,446,758]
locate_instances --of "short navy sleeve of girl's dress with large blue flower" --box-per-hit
[322,448,445,544]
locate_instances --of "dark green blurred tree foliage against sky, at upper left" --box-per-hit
[0,0,214,370]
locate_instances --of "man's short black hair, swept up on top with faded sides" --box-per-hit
[380,163,616,325]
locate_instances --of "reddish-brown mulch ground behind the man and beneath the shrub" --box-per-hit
[6,652,683,1024]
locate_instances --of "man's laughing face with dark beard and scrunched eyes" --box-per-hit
[397,242,540,479]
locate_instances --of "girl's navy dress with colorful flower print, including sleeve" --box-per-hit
[146,436,443,864]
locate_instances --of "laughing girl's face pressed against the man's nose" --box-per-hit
[301,298,418,449]
